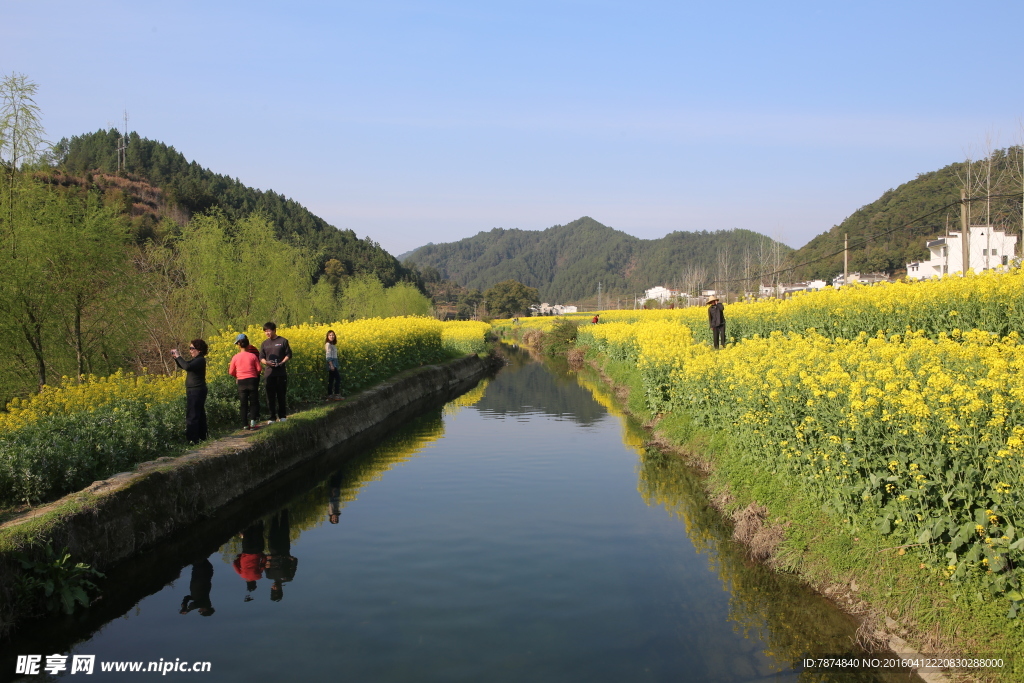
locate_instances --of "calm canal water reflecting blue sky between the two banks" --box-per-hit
[0,351,917,683]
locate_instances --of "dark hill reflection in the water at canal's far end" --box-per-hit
[476,349,605,425]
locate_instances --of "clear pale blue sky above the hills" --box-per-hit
[0,0,1024,255]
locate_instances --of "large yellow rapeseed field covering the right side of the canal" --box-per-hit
[580,270,1024,614]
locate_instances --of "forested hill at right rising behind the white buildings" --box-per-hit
[791,147,1022,280]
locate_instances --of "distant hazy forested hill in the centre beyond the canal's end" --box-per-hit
[404,216,792,303]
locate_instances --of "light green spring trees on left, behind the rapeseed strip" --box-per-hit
[0,75,430,404]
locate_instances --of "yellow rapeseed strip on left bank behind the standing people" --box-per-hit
[0,317,488,505]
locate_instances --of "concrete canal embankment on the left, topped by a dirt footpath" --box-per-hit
[0,355,496,637]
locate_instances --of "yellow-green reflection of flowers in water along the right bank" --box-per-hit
[638,450,906,682]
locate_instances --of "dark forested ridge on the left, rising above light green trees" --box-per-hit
[56,129,414,287]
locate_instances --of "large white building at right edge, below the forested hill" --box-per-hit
[906,225,1017,280]
